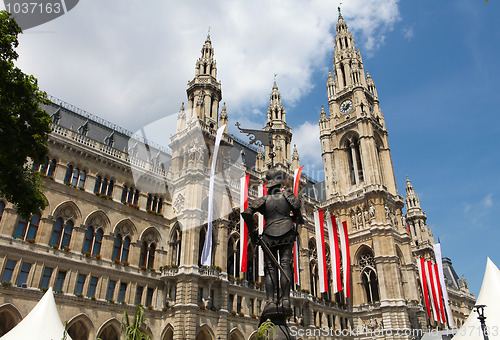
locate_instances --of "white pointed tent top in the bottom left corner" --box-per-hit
[2,287,71,340]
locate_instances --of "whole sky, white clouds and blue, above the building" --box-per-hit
[4,0,500,294]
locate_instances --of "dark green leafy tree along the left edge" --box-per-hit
[0,11,51,217]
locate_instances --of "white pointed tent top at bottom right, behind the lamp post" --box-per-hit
[452,258,500,340]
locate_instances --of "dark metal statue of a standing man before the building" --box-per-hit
[241,169,304,317]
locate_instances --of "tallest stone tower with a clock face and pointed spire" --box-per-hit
[319,8,425,338]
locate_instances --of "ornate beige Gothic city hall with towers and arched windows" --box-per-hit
[0,14,475,340]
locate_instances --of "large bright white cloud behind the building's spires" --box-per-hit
[13,0,399,144]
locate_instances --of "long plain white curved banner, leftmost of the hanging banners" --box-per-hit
[201,125,226,266]
